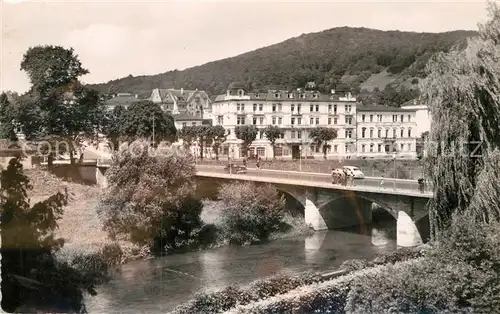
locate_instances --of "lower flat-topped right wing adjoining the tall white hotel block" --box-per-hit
[356,106,419,159]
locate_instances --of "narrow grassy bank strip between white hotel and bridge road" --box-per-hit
[197,159,422,180]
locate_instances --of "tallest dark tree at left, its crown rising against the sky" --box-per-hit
[18,46,105,165]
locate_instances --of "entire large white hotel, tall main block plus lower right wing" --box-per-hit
[212,83,426,159]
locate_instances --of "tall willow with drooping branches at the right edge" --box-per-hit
[422,3,500,239]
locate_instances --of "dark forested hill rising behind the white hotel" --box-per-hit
[88,27,477,103]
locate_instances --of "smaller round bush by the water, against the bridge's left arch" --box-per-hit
[219,182,285,245]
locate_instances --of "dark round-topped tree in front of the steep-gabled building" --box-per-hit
[123,100,177,144]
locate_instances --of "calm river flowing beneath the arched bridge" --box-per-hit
[86,220,396,314]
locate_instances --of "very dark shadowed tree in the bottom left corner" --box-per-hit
[0,158,107,313]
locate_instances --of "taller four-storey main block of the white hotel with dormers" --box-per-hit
[212,83,358,159]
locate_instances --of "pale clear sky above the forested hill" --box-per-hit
[0,0,487,93]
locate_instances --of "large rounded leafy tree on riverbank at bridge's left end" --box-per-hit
[98,140,201,251]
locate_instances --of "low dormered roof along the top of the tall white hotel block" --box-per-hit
[214,90,358,102]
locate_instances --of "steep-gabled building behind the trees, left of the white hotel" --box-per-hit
[149,88,212,129]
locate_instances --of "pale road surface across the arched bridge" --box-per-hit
[196,165,428,191]
